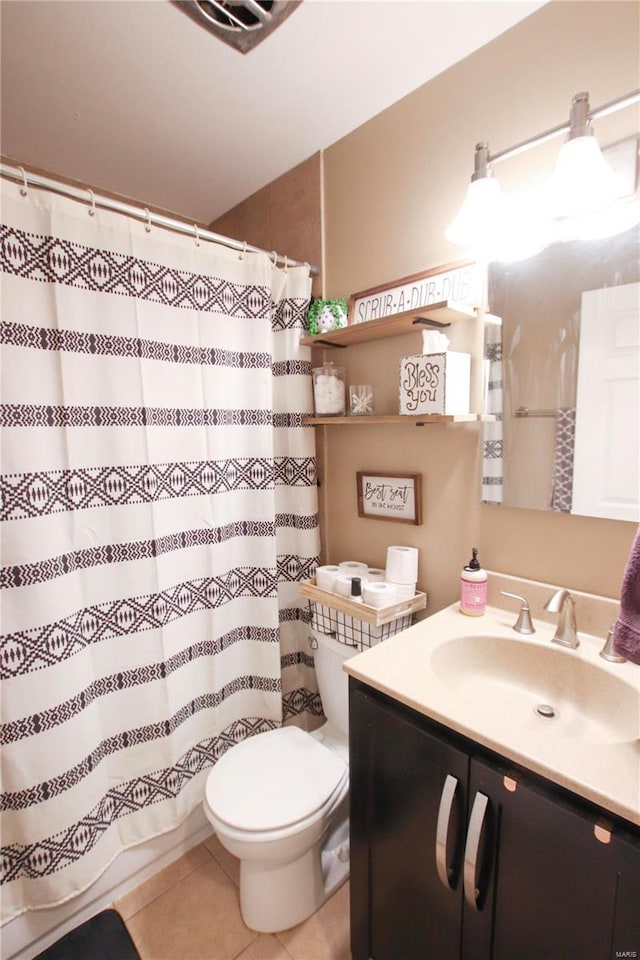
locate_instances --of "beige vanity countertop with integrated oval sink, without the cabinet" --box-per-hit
[344,604,640,826]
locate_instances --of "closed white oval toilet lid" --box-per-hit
[206,727,347,830]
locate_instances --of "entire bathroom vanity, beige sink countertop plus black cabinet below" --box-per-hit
[346,608,640,960]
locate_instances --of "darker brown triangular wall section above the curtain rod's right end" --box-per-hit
[210,153,322,297]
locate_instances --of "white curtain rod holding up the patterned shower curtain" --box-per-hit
[0,163,320,277]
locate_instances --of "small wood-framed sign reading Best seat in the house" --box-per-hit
[356,470,422,526]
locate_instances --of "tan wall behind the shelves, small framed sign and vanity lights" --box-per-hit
[324,0,640,611]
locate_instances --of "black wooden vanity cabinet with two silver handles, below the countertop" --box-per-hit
[350,678,640,960]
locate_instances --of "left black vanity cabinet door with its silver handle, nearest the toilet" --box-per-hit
[350,693,468,960]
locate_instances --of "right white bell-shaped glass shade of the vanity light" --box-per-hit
[547,136,629,217]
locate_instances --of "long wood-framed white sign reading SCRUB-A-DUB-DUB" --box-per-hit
[348,261,483,324]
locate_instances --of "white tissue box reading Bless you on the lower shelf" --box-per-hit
[400,351,471,416]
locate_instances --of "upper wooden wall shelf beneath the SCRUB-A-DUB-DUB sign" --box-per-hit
[300,300,476,347]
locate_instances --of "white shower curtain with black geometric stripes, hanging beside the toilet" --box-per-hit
[0,183,320,920]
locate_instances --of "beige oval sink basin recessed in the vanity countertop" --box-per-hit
[430,636,640,747]
